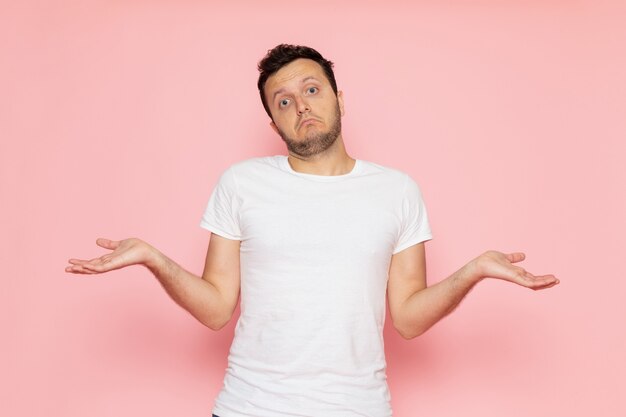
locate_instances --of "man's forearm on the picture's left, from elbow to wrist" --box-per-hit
[146,249,228,330]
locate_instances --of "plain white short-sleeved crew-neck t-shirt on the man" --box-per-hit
[201,156,431,417]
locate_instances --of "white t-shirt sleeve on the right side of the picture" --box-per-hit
[393,175,432,254]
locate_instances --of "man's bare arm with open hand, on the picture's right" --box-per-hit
[388,243,559,339]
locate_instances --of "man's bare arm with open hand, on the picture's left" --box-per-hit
[65,234,240,330]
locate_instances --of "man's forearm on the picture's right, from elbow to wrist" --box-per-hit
[396,264,479,339]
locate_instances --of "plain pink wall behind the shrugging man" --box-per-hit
[0,0,626,417]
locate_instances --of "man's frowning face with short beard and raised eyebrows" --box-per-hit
[265,59,344,157]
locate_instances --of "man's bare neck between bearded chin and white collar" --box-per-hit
[287,136,356,175]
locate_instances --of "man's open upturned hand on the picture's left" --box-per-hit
[65,238,157,274]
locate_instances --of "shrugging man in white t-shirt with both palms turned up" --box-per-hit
[66,45,558,417]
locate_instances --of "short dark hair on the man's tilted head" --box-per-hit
[257,43,337,119]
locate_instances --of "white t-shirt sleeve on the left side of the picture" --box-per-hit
[200,167,241,240]
